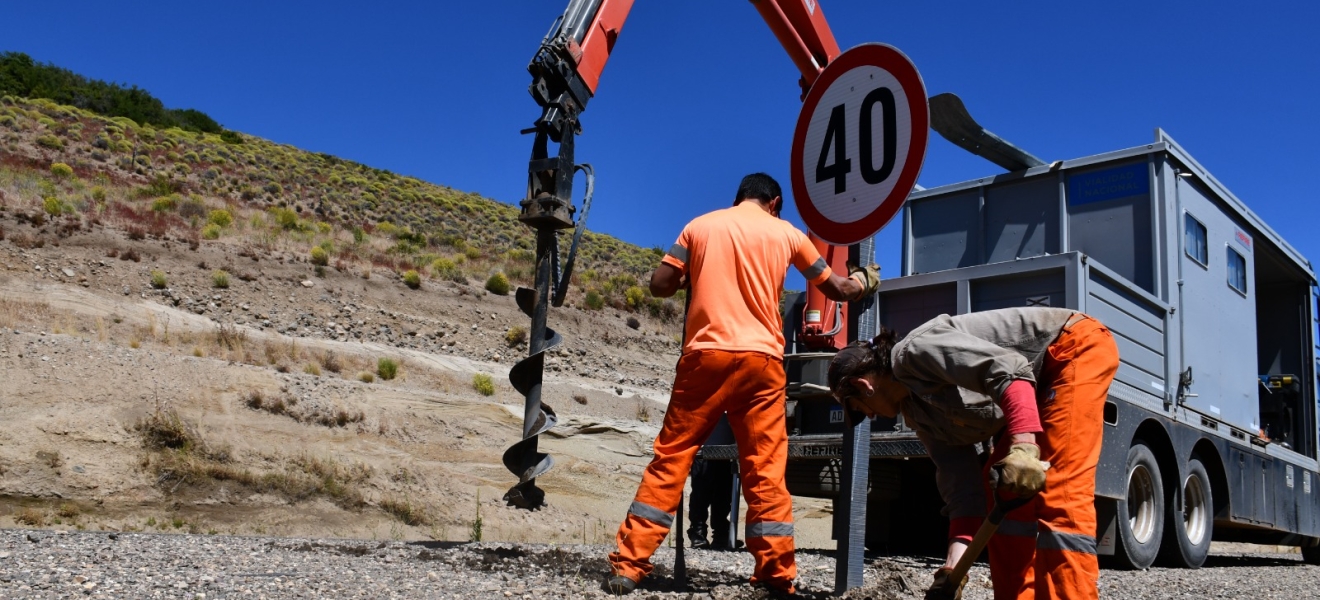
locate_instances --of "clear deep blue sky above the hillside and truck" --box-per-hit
[0,0,1320,286]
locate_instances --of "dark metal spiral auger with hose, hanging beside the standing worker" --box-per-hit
[504,165,595,510]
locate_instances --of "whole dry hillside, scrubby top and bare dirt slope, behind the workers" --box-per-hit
[0,91,855,547]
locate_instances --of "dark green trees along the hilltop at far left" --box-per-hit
[0,51,224,133]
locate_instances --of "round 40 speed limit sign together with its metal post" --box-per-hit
[789,44,931,593]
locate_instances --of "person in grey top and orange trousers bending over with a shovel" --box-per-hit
[829,307,1118,599]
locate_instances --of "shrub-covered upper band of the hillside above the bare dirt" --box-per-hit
[0,96,678,319]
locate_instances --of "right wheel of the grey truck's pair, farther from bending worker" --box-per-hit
[1160,458,1214,568]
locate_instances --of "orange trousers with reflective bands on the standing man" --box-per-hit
[610,349,797,591]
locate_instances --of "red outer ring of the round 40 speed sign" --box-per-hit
[789,44,931,245]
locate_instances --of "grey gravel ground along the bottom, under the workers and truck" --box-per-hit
[0,530,1320,600]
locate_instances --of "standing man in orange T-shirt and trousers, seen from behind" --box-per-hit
[605,173,879,595]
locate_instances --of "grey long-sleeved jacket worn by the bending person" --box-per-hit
[891,307,1077,517]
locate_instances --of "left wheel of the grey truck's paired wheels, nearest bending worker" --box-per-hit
[1114,440,1164,568]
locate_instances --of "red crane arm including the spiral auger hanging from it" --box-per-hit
[504,0,847,509]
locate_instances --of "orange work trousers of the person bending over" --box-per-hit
[986,315,1118,600]
